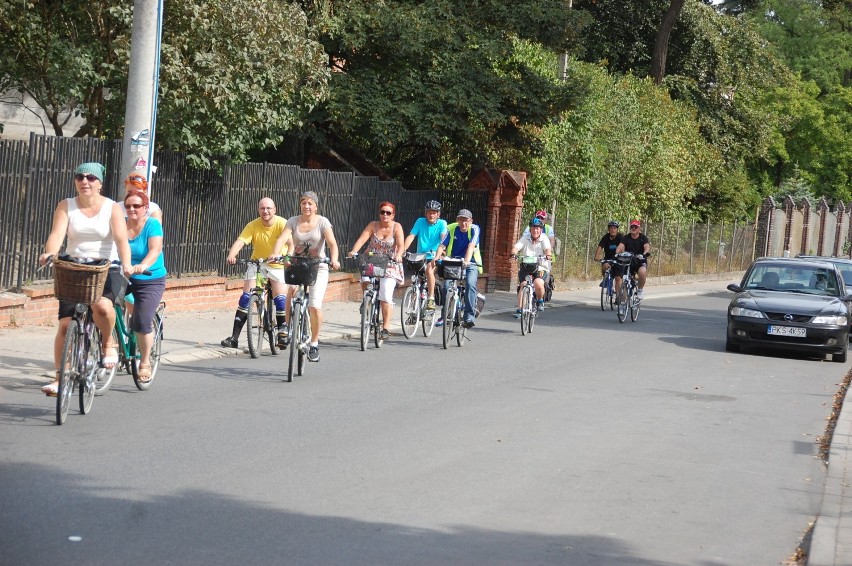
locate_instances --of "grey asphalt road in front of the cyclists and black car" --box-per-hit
[0,294,846,566]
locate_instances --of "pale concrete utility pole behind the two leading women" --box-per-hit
[121,0,163,191]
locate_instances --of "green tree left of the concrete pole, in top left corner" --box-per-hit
[0,0,132,137]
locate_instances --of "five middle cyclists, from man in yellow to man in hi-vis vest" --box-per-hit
[221,197,483,362]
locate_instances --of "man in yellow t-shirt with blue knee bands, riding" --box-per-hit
[222,197,290,348]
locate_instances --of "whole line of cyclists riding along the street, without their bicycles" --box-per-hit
[39,163,650,395]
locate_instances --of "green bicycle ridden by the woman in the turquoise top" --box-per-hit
[95,265,166,396]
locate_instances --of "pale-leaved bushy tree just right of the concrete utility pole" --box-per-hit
[157,0,329,164]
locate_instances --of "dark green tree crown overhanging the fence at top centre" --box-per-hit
[298,0,582,191]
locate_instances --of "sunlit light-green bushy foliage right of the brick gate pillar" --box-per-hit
[530,62,721,222]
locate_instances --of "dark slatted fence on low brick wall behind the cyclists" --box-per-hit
[0,134,488,292]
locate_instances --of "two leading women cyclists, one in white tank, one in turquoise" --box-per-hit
[39,162,167,397]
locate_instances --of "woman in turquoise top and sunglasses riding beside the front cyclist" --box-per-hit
[124,190,166,382]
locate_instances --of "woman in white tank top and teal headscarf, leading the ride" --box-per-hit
[38,163,133,397]
